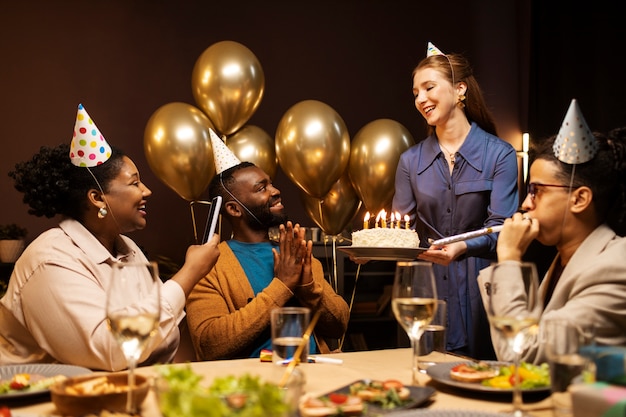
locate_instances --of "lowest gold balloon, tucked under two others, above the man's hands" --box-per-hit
[300,172,361,236]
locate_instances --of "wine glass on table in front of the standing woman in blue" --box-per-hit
[391,261,437,385]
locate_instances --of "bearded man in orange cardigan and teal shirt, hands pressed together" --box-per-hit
[187,161,349,360]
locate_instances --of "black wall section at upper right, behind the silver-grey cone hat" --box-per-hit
[529,0,626,138]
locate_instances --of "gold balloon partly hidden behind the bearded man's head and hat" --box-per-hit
[226,125,277,178]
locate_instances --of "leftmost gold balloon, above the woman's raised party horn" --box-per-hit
[144,103,215,201]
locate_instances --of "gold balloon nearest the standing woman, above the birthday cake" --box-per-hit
[348,119,415,213]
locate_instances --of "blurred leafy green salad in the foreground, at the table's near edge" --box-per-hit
[158,365,290,417]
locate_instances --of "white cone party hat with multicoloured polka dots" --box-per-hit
[70,104,111,168]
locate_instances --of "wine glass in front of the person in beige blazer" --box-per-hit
[487,262,543,417]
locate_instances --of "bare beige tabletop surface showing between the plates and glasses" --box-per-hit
[4,348,552,417]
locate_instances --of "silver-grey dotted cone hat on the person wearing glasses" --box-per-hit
[552,99,598,164]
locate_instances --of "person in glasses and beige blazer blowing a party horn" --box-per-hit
[479,115,626,364]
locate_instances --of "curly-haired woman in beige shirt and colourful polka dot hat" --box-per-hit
[0,106,219,371]
